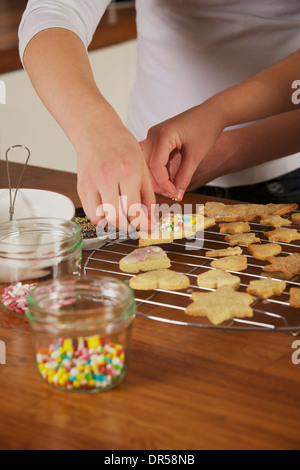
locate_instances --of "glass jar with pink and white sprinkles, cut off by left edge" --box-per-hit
[0,218,83,317]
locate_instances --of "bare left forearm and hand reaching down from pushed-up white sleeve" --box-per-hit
[19,0,155,230]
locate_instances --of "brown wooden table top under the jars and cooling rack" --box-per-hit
[0,162,300,450]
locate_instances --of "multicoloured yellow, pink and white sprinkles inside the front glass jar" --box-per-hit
[36,336,125,391]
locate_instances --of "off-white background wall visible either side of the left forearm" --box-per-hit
[0,41,136,173]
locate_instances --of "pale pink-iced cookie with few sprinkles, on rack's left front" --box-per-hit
[119,246,171,274]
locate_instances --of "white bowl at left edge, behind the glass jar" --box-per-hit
[0,189,75,223]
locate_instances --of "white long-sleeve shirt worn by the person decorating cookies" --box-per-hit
[19,0,300,187]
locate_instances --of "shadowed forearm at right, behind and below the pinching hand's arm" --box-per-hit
[188,110,300,191]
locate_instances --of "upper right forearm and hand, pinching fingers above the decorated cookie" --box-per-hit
[144,51,300,200]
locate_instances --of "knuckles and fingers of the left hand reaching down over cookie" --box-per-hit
[78,152,156,233]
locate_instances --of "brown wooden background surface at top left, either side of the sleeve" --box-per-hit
[0,0,137,74]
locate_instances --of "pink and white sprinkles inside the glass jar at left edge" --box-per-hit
[1,282,37,315]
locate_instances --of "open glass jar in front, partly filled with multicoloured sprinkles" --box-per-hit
[26,277,136,393]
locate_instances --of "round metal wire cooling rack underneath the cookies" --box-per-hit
[84,211,300,336]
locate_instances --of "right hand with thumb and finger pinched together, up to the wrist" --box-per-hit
[142,100,225,201]
